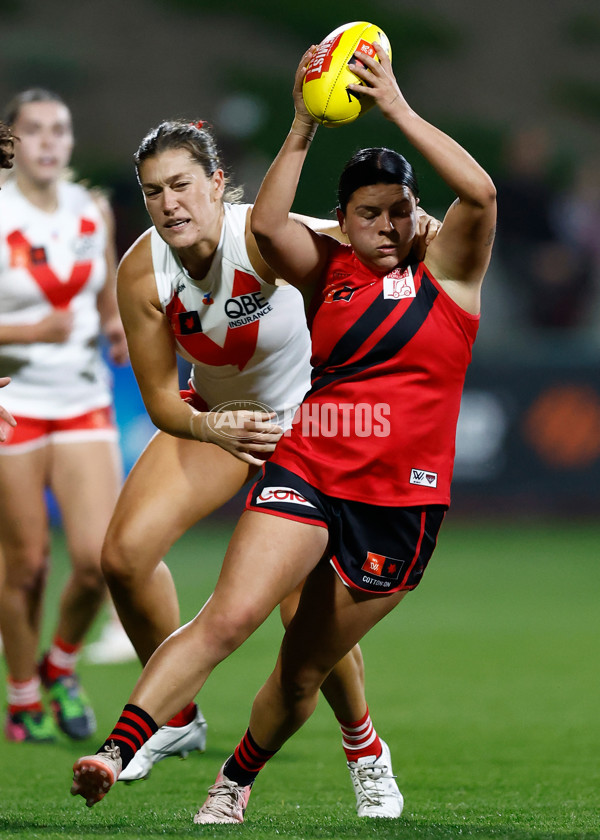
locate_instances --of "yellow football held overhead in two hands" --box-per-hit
[302,21,392,126]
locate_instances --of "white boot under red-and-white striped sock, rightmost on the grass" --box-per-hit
[348,739,404,819]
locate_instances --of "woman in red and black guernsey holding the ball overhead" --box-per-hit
[72,45,496,823]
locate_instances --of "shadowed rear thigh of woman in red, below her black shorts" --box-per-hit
[282,562,406,677]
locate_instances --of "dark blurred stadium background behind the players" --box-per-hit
[0,0,600,516]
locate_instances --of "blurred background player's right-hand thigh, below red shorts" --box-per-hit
[50,439,122,564]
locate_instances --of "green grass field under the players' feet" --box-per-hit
[0,516,600,840]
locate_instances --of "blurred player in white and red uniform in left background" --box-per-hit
[0,89,127,742]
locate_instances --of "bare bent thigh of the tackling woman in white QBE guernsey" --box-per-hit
[107,432,254,566]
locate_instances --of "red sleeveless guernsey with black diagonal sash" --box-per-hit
[270,244,479,506]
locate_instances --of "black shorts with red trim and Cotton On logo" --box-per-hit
[246,461,446,593]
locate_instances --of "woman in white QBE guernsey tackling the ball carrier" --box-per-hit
[102,121,435,816]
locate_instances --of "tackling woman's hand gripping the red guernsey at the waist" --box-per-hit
[190,409,283,467]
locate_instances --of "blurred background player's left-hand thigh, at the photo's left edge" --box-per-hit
[0,445,48,565]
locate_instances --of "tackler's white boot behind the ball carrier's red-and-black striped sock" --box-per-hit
[119,706,207,782]
